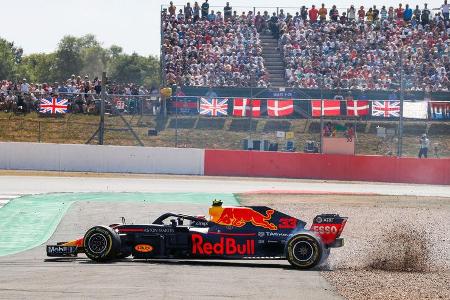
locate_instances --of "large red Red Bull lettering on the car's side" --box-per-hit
[192,233,255,255]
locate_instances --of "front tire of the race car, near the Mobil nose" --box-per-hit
[83,225,121,262]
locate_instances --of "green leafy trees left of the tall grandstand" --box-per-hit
[0,34,159,87]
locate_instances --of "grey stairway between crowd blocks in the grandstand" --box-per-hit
[259,33,286,87]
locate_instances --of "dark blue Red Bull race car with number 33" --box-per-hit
[47,201,347,269]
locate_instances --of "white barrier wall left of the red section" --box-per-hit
[0,142,205,175]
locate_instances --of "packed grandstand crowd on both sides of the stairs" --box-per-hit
[161,0,450,91]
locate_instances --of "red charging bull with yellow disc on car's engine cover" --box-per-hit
[209,206,278,230]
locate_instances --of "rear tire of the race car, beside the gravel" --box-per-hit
[286,234,324,269]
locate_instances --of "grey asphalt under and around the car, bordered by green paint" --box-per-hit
[0,202,340,299]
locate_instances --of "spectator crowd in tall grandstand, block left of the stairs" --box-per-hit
[161,0,268,87]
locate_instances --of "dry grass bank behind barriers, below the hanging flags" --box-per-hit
[0,113,450,157]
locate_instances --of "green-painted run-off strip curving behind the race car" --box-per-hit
[0,193,238,256]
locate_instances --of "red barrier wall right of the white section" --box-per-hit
[205,150,450,184]
